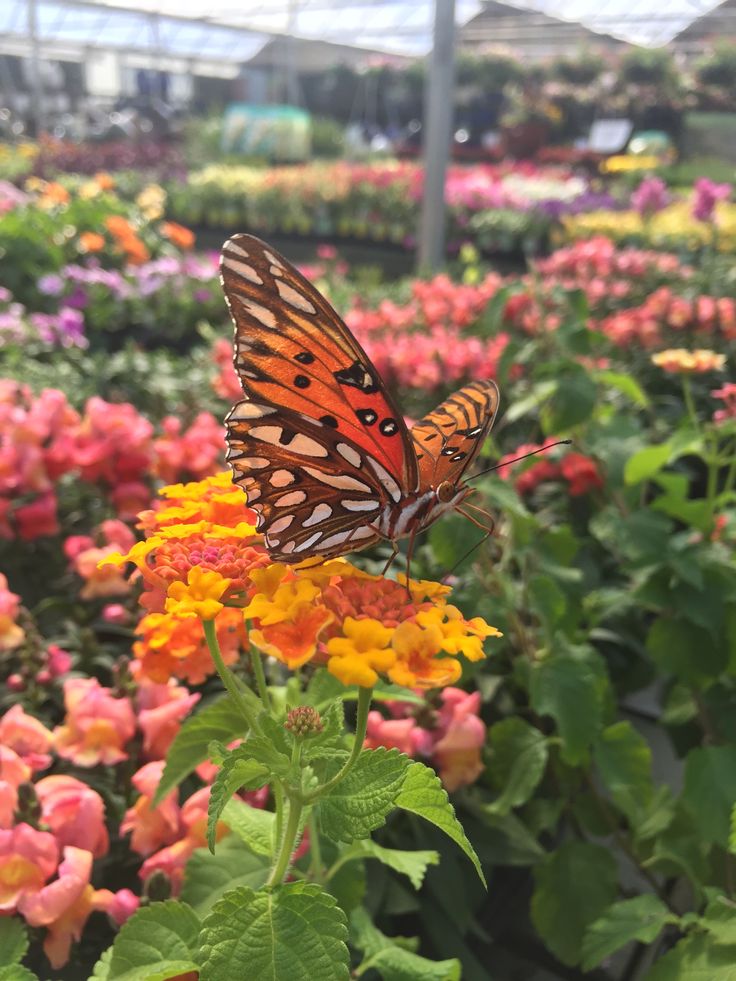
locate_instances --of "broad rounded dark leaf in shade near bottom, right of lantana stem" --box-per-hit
[531,842,617,966]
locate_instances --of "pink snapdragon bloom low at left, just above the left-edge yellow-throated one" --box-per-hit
[36,774,109,858]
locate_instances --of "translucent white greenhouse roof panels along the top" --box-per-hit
[0,0,722,64]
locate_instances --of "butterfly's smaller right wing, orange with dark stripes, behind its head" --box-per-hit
[411,380,498,487]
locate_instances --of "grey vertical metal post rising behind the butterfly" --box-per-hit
[418,0,455,272]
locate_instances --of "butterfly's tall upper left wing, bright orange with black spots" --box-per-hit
[220,235,418,492]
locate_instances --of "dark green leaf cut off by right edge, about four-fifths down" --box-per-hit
[682,745,736,848]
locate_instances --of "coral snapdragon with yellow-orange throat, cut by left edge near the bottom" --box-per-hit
[0,824,59,914]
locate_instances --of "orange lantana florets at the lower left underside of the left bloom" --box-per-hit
[133,608,247,685]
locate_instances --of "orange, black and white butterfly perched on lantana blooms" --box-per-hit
[220,235,499,563]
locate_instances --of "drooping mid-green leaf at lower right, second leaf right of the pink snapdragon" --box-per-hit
[593,722,654,830]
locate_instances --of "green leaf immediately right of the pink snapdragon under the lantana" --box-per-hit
[487,718,547,814]
